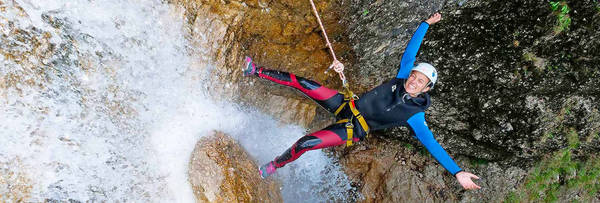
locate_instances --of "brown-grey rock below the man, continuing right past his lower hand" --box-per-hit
[334,137,527,202]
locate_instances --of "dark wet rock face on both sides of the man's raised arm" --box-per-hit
[348,1,600,161]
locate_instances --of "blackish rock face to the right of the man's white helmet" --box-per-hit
[421,1,600,160]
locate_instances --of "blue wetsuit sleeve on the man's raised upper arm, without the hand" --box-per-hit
[396,22,429,78]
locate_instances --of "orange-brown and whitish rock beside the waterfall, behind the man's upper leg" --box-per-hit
[171,0,350,127]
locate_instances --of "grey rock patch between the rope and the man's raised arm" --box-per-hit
[342,0,444,91]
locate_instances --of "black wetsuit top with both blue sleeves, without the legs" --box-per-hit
[356,22,461,175]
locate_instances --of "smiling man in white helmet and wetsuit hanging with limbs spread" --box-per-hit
[243,13,480,189]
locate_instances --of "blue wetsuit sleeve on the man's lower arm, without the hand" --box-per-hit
[408,112,462,175]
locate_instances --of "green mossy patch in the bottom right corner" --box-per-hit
[504,129,600,202]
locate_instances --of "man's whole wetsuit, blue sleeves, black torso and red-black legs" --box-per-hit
[256,22,461,175]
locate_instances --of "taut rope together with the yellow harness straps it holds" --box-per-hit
[310,0,369,146]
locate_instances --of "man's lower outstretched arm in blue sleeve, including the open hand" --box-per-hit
[408,112,480,190]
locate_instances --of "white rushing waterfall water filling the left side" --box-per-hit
[0,0,352,202]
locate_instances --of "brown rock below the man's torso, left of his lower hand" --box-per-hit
[336,137,458,202]
